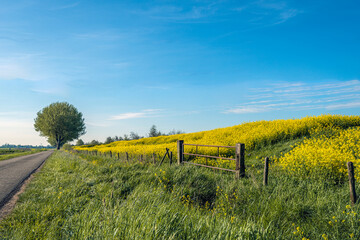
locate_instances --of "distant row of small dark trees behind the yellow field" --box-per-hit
[76,125,185,146]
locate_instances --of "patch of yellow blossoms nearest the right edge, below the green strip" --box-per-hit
[278,127,360,180]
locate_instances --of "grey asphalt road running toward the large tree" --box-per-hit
[0,151,53,208]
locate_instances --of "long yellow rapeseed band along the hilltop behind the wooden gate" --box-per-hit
[75,115,360,170]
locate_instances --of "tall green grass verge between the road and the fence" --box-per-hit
[0,148,360,239]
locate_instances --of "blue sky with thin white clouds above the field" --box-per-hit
[0,0,360,145]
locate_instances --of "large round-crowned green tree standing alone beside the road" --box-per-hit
[34,102,85,149]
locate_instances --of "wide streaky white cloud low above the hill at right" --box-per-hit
[224,80,360,114]
